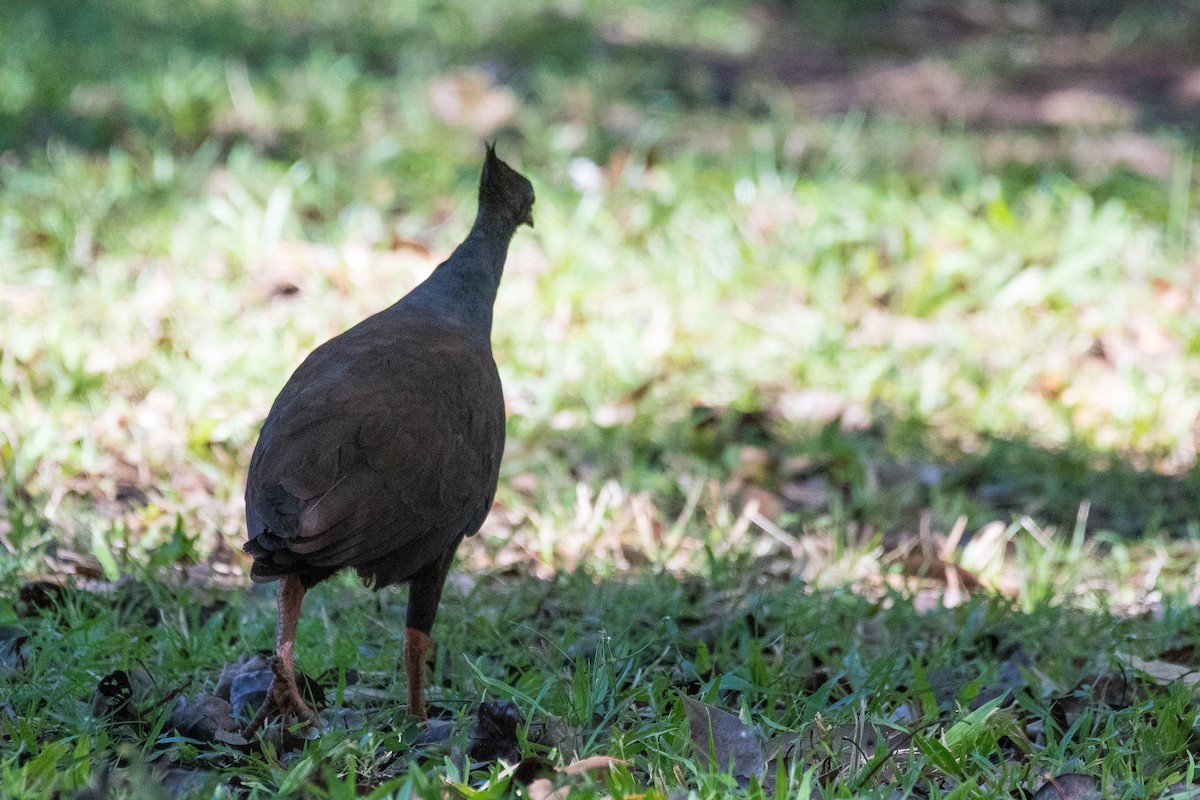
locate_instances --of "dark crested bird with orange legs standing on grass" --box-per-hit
[244,143,534,739]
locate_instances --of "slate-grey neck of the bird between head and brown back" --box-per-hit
[395,210,514,344]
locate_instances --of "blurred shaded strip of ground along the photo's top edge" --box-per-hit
[0,0,1200,154]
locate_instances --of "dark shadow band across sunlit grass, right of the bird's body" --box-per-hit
[530,400,1200,537]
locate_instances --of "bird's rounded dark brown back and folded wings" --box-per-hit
[246,325,504,577]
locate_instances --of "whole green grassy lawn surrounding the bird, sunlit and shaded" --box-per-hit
[0,0,1200,798]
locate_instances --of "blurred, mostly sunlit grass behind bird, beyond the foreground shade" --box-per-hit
[0,0,1200,571]
